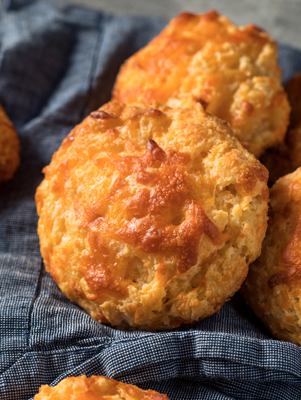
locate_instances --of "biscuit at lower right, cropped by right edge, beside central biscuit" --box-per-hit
[243,168,301,345]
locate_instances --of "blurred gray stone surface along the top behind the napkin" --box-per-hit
[60,0,301,48]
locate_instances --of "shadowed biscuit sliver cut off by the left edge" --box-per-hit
[0,105,20,183]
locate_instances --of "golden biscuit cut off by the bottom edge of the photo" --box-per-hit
[34,375,169,400]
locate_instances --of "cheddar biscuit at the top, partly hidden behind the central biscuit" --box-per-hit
[113,11,290,157]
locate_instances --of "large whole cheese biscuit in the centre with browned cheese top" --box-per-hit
[36,103,268,330]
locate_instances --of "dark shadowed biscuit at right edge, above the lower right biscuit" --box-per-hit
[261,73,301,184]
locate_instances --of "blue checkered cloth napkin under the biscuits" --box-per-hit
[0,0,301,400]
